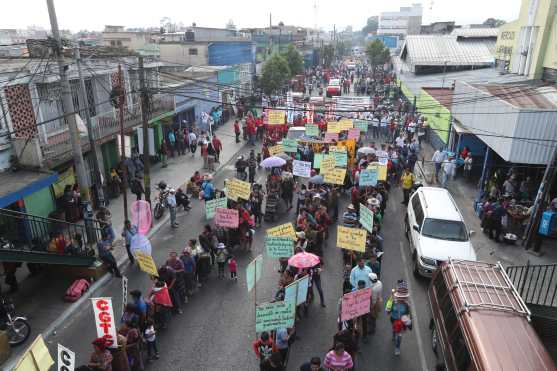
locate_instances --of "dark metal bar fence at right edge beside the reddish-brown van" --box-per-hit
[507,263,557,307]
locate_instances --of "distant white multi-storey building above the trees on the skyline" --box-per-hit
[377,4,422,38]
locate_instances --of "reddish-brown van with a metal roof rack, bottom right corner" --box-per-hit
[428,259,557,371]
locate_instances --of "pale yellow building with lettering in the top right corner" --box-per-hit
[495,0,557,82]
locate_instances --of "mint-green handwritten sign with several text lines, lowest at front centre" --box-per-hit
[255,301,295,332]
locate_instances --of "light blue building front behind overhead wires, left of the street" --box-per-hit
[175,77,221,130]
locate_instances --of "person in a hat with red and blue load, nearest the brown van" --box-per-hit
[385,280,412,356]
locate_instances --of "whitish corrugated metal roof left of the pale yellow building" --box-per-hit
[400,35,495,66]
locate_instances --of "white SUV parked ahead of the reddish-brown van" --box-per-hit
[404,187,476,277]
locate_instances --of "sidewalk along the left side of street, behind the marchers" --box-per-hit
[4,120,245,366]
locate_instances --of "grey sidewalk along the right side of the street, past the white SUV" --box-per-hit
[415,142,557,267]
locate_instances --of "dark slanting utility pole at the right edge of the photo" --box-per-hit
[523,148,557,253]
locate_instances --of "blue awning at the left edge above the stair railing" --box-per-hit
[0,170,58,207]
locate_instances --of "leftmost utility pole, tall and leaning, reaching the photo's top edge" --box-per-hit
[46,0,92,218]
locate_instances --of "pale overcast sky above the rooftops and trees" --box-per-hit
[0,0,521,31]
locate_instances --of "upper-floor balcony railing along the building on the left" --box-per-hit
[41,95,174,166]
